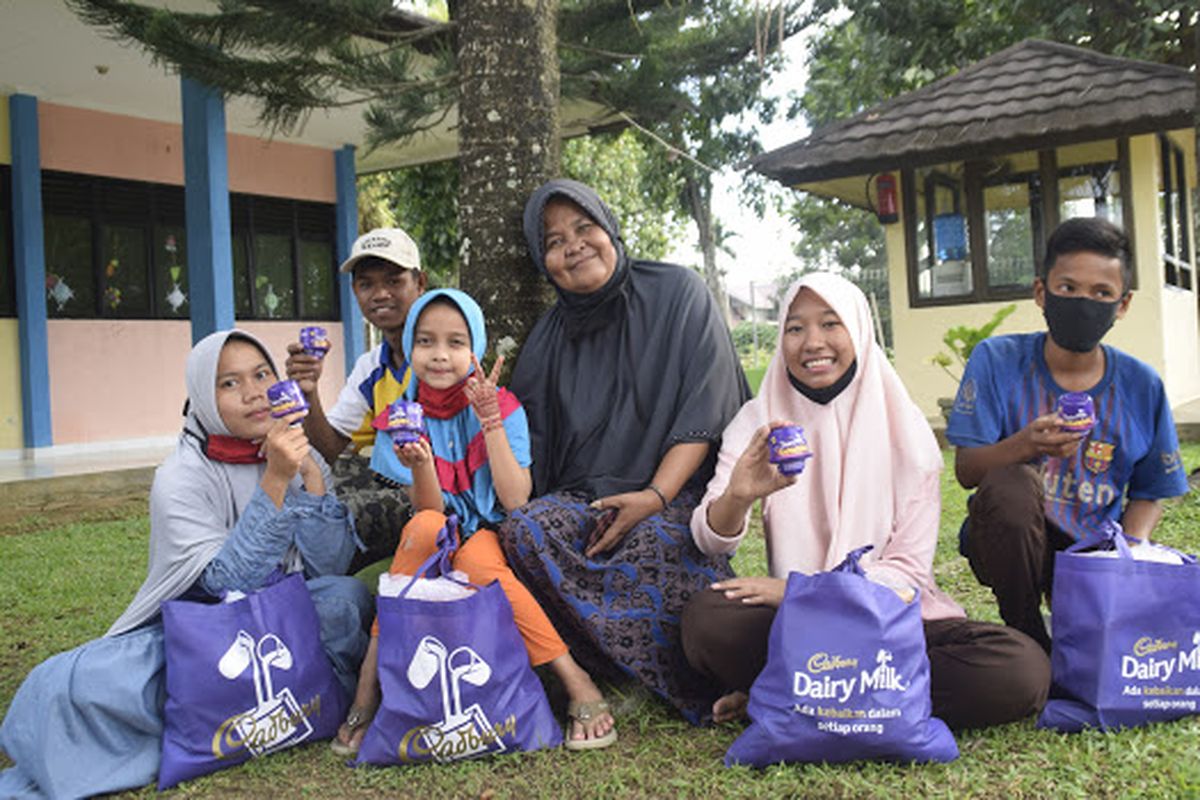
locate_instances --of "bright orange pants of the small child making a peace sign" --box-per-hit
[371,510,568,667]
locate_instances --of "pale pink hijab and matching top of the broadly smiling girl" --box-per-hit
[692,272,962,619]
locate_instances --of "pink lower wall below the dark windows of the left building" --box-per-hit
[46,319,346,447]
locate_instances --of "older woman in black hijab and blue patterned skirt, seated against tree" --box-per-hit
[500,180,750,722]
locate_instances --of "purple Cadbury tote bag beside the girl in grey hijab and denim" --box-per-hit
[158,573,347,789]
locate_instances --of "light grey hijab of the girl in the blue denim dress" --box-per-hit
[108,330,307,636]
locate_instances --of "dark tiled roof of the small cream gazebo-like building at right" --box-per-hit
[750,40,1196,185]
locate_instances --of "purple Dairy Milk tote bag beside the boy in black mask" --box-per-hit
[1038,525,1200,733]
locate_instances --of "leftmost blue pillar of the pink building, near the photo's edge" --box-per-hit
[8,95,54,447]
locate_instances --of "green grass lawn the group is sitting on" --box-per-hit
[0,444,1200,800]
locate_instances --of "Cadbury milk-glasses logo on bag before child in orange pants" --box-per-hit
[397,636,517,763]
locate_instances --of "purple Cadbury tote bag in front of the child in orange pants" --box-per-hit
[359,516,563,764]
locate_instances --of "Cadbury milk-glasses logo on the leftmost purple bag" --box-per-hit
[212,631,320,758]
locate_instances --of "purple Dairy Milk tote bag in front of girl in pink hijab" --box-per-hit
[725,546,959,766]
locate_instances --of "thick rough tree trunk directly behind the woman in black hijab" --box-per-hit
[450,0,560,365]
